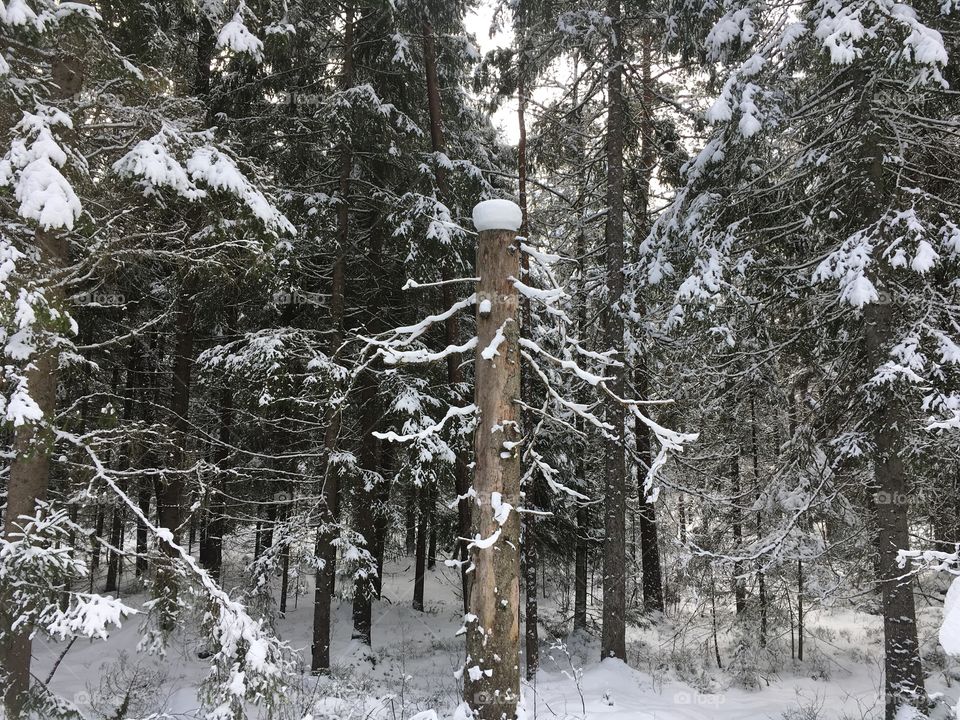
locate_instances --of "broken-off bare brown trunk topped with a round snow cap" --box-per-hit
[463,200,521,720]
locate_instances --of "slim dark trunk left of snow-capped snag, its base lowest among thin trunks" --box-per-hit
[310,4,354,673]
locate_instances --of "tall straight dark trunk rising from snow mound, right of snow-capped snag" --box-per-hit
[600,0,627,660]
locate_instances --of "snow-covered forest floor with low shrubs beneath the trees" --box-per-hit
[34,544,960,720]
